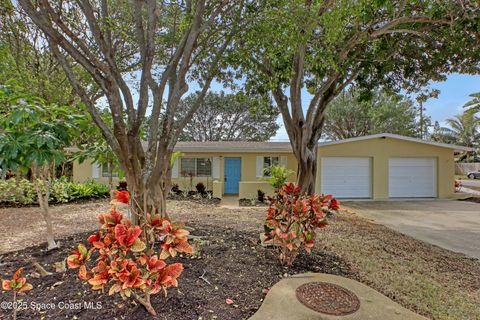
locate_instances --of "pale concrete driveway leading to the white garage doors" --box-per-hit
[343,200,480,259]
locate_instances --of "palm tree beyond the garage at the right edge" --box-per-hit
[442,110,480,161]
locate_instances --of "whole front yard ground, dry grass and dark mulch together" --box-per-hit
[0,201,480,320]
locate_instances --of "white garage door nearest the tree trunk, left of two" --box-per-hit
[321,157,372,198]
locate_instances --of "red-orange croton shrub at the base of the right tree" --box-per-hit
[265,183,340,266]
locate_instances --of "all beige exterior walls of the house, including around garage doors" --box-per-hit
[73,138,455,199]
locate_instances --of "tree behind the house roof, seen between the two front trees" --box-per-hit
[180,92,279,141]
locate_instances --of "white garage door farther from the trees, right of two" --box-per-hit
[388,158,437,198]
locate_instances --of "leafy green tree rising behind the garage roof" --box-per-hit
[323,90,419,140]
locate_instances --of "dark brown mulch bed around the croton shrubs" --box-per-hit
[0,223,355,320]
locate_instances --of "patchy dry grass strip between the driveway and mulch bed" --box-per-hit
[322,216,480,320]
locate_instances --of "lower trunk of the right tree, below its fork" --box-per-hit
[295,144,317,195]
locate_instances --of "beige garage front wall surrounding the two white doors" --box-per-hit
[315,138,455,200]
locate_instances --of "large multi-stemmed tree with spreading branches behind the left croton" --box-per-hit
[18,0,243,220]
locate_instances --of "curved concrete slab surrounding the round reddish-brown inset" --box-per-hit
[249,273,427,320]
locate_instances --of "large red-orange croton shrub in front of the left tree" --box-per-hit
[67,190,192,315]
